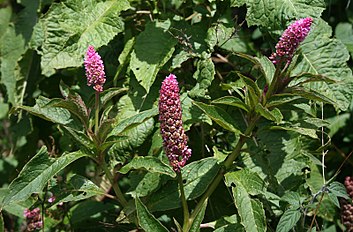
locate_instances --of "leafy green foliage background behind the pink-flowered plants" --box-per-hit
[0,0,353,231]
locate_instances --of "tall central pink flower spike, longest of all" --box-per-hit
[159,74,191,172]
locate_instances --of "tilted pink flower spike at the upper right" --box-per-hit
[270,17,313,64]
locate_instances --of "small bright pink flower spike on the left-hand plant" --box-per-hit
[84,45,105,92]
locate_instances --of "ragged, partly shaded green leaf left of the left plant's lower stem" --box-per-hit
[50,175,105,205]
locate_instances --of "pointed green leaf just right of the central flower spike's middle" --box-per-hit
[193,101,241,134]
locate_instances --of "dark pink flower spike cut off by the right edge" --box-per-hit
[340,176,353,232]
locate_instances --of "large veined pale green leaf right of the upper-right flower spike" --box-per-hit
[292,19,353,111]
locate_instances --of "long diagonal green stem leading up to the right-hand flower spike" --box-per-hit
[183,116,259,232]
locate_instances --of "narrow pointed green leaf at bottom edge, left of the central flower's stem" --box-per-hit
[135,197,168,232]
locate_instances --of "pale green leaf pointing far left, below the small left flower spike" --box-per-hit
[17,96,72,125]
